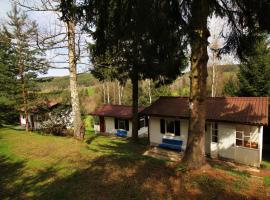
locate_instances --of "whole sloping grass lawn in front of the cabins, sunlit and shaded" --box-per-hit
[0,127,270,200]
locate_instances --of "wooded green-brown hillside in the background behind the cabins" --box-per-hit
[35,65,239,114]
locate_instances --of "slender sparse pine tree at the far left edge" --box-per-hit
[4,4,47,131]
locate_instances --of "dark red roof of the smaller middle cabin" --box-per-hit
[90,104,144,119]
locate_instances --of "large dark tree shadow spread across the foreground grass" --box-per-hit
[0,138,262,200]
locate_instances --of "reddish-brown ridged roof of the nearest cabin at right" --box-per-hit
[142,97,268,125]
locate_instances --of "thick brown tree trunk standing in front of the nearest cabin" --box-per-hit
[183,0,210,169]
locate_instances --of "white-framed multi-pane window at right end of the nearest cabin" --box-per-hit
[235,127,258,149]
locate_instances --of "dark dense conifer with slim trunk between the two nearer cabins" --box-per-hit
[82,0,186,140]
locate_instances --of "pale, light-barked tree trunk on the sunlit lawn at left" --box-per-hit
[67,20,84,140]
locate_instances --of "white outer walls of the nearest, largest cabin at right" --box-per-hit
[149,117,263,167]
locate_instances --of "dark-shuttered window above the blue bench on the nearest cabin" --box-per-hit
[160,119,180,136]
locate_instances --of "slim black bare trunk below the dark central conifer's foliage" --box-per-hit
[131,69,139,141]
